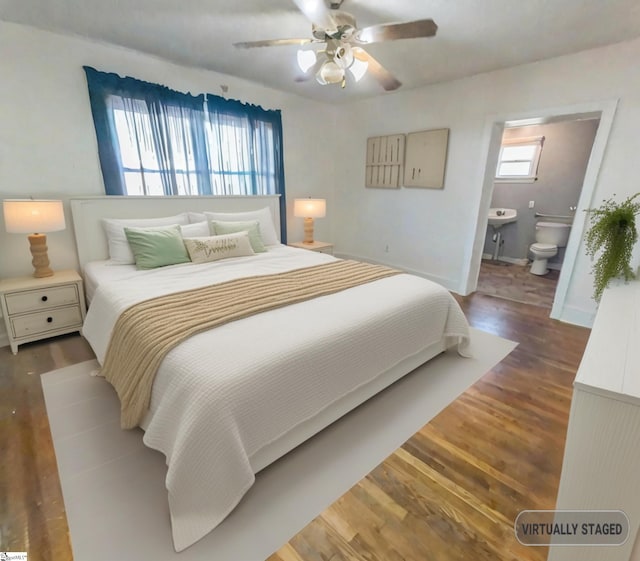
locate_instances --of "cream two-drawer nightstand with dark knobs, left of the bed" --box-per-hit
[0,271,86,355]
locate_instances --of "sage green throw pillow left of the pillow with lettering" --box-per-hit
[124,225,191,269]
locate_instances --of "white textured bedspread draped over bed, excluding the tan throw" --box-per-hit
[83,246,468,551]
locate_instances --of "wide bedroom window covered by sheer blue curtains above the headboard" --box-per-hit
[84,66,286,213]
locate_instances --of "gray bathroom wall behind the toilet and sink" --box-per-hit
[484,119,599,268]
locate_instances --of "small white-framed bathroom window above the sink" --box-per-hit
[496,136,544,183]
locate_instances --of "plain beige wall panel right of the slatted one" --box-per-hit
[403,129,449,189]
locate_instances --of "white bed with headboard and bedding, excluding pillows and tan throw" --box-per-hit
[71,197,469,551]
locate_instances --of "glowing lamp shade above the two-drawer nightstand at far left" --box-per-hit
[2,199,65,234]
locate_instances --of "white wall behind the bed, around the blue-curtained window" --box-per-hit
[0,22,335,345]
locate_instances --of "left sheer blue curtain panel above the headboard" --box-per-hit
[84,66,211,195]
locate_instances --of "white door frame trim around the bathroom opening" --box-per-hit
[465,100,617,326]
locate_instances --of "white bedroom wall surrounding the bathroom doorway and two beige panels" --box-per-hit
[333,40,640,323]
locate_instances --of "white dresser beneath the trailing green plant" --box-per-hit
[548,281,640,561]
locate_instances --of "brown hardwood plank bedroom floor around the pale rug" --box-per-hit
[0,293,589,561]
